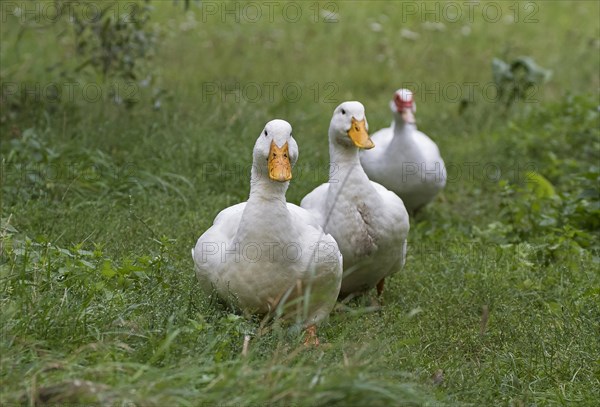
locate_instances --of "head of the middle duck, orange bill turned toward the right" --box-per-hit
[329,102,375,150]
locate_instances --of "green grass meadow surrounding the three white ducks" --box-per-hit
[0,1,600,406]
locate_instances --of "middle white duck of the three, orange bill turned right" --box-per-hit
[300,102,409,297]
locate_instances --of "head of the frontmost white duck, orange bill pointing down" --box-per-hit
[253,119,298,182]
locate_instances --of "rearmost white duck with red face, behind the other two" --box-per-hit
[360,89,446,213]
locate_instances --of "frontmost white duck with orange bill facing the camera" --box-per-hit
[192,120,342,345]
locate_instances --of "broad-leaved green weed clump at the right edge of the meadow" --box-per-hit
[476,97,600,255]
